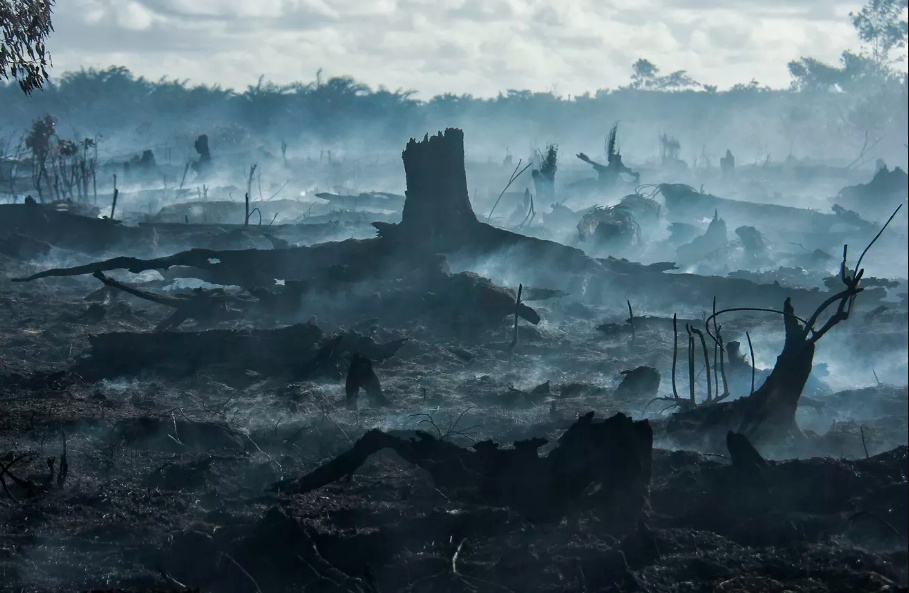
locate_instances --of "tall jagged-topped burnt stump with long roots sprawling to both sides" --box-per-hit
[7,129,872,308]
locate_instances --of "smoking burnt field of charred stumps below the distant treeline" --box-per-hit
[0,70,909,592]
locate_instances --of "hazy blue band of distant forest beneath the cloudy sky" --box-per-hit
[0,0,909,167]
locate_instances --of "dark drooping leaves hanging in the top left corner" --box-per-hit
[0,0,54,94]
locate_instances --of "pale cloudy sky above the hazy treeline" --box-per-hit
[49,0,861,98]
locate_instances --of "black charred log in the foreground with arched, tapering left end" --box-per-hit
[273,412,653,534]
